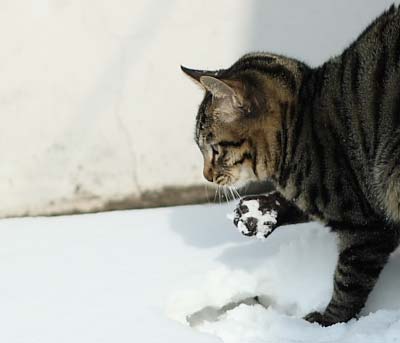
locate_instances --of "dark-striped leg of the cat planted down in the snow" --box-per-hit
[305,225,398,326]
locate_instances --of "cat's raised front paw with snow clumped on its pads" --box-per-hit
[233,196,278,239]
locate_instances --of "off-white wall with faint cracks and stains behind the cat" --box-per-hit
[0,0,391,216]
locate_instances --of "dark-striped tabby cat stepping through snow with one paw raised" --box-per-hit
[181,5,400,326]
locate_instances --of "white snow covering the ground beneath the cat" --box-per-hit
[0,203,400,343]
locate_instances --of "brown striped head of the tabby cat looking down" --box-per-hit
[182,57,300,187]
